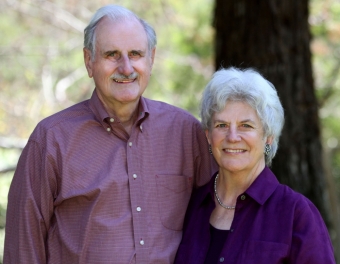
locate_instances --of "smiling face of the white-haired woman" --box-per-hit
[206,101,271,173]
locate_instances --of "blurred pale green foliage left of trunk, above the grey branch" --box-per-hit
[0,0,213,138]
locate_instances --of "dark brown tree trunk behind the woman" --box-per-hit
[214,0,331,227]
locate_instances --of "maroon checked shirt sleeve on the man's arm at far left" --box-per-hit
[4,137,53,264]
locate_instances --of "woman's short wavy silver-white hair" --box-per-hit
[200,67,284,166]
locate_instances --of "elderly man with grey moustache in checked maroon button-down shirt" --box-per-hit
[4,5,215,264]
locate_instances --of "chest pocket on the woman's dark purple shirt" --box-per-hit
[240,240,288,264]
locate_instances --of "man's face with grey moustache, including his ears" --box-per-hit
[84,18,155,109]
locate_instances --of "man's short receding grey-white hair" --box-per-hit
[84,5,157,60]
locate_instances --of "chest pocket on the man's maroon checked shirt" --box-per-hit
[156,175,192,231]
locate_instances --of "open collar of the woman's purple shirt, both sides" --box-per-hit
[199,167,280,208]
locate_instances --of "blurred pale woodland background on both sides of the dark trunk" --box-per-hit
[0,0,340,263]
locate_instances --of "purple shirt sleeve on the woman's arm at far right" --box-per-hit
[289,199,336,264]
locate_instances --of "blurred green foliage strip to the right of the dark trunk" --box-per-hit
[309,0,340,244]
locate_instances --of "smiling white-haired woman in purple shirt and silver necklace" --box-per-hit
[175,68,335,264]
